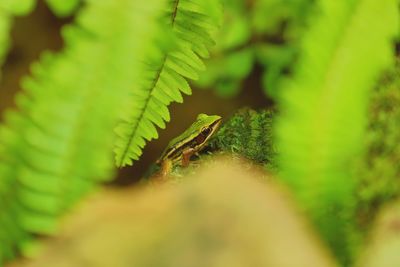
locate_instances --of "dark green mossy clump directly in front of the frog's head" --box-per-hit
[209,108,276,169]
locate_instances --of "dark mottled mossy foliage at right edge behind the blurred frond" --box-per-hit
[357,62,400,228]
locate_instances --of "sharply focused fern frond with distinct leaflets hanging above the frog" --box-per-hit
[115,0,221,167]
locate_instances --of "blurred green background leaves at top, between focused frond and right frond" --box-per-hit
[197,0,315,97]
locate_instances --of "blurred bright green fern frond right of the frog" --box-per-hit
[276,0,399,264]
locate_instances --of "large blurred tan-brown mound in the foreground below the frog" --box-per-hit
[10,159,336,267]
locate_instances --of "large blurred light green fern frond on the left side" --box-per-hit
[0,0,163,265]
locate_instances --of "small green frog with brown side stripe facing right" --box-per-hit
[157,114,222,177]
